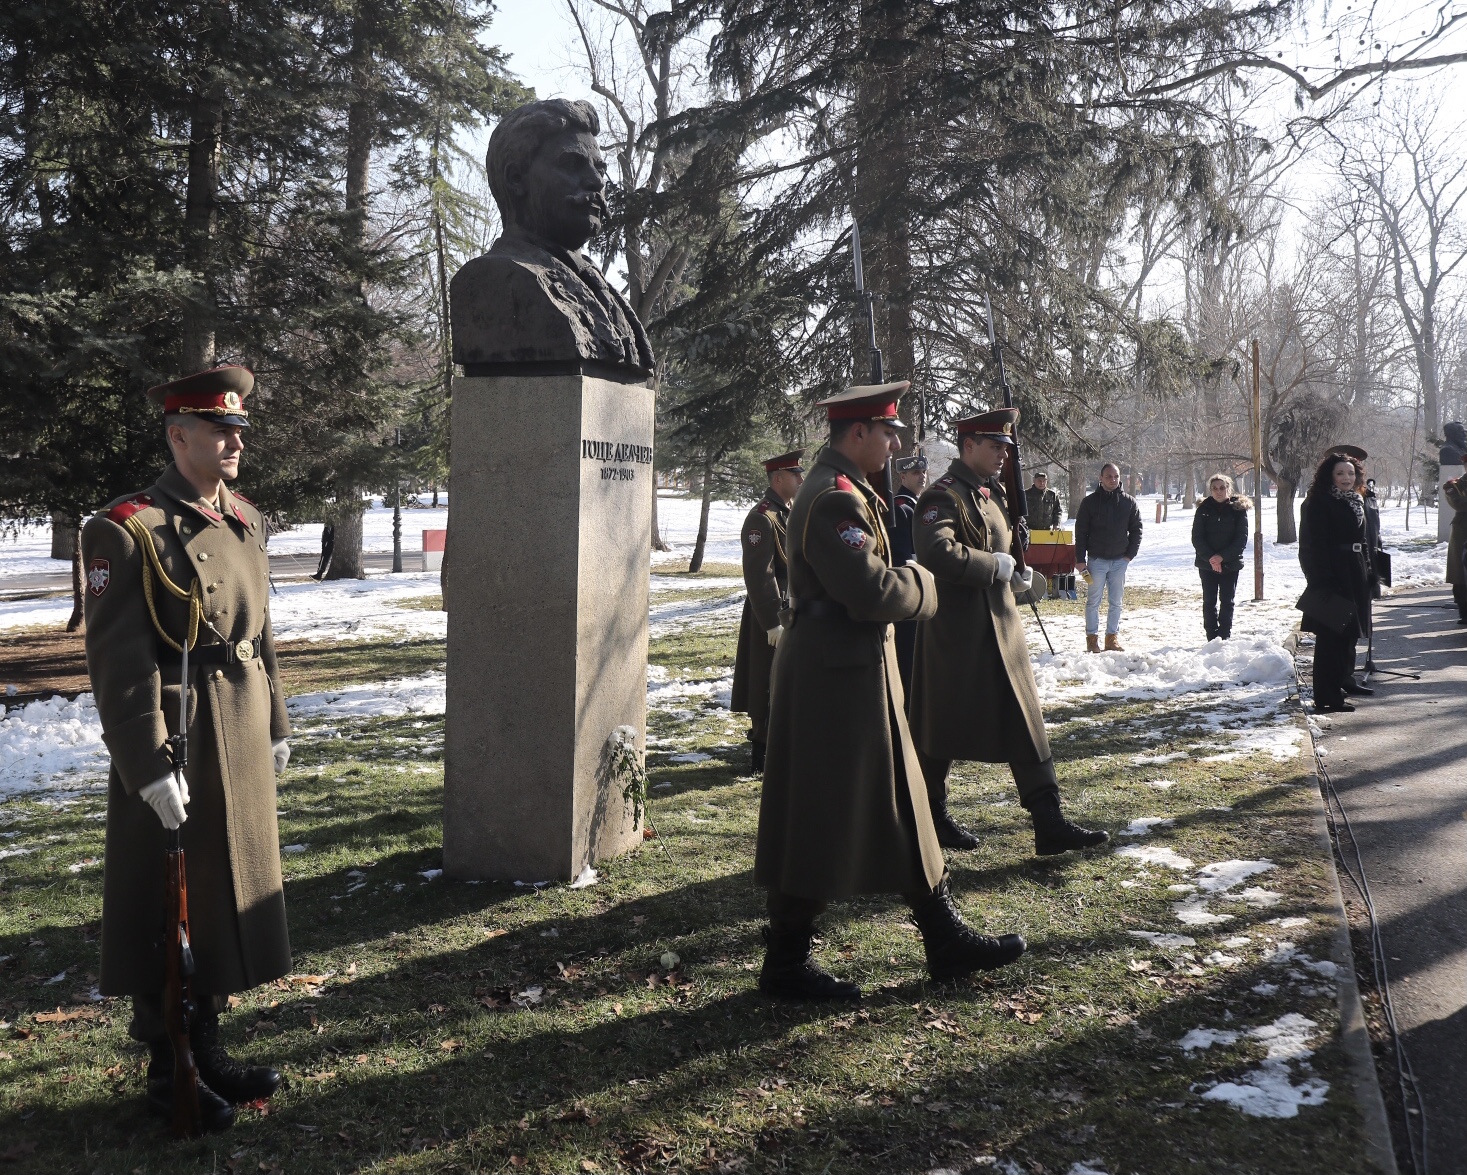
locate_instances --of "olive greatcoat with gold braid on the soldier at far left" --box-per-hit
[82,465,290,996]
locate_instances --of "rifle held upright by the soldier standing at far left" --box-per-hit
[163,634,204,1138]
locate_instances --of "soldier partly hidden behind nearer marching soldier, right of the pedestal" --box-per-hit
[729,449,805,775]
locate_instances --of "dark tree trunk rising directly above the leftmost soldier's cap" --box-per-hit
[180,79,224,374]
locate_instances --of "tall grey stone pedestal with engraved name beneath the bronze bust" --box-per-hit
[443,374,653,882]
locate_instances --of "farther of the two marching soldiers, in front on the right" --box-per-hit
[910,408,1111,857]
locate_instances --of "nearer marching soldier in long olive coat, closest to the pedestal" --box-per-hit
[754,383,1024,999]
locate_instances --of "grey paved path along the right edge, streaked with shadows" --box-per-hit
[1320,587,1467,1175]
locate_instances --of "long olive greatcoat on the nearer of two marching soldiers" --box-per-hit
[754,449,943,899]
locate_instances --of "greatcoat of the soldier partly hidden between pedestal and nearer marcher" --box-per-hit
[729,490,789,742]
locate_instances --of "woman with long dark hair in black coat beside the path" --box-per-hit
[1298,453,1375,711]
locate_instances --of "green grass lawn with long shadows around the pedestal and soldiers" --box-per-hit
[0,580,1366,1175]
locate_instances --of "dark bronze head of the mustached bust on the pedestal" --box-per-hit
[484,98,607,251]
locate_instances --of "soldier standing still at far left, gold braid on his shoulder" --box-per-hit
[82,367,290,1130]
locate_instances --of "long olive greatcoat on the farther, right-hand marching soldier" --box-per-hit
[910,461,1050,763]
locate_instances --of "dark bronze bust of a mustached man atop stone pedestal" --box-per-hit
[449,98,653,378]
